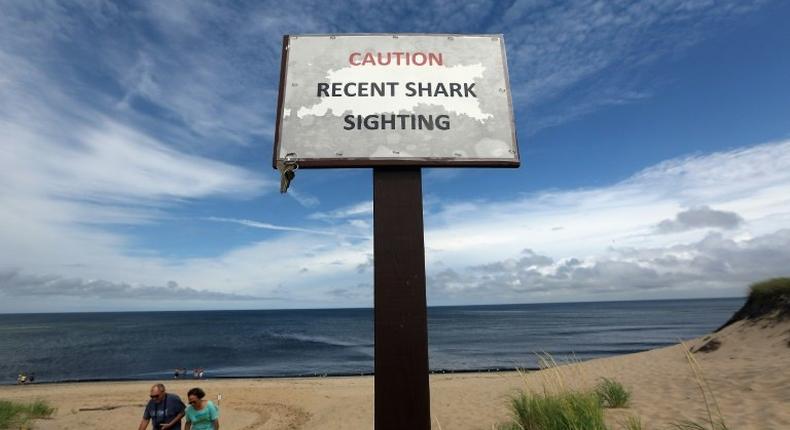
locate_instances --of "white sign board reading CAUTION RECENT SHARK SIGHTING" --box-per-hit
[274,34,519,167]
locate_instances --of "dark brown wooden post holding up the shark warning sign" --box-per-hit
[373,167,431,430]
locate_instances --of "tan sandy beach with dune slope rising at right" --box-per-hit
[0,320,790,430]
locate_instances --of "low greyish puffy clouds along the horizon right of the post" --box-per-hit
[429,230,790,303]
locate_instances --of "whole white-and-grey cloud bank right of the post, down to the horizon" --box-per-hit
[418,141,790,303]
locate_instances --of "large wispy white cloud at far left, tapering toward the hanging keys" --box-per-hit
[0,2,274,306]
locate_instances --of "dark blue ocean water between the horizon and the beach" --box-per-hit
[0,298,744,384]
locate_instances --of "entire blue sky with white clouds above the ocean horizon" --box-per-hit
[0,0,790,312]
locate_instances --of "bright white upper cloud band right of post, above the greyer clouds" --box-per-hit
[426,141,790,264]
